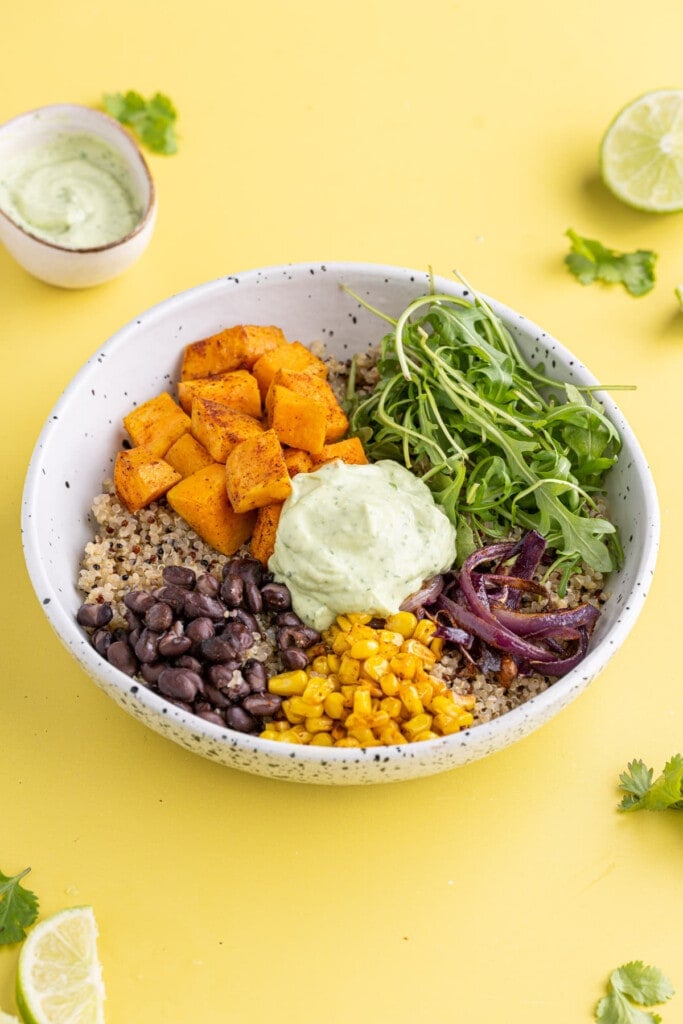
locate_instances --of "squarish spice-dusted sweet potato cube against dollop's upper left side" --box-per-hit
[225,430,292,512]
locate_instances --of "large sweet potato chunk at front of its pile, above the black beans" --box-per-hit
[167,462,256,555]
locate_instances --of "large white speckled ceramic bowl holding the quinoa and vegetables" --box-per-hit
[23,263,659,784]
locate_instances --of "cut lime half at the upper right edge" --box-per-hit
[600,89,683,213]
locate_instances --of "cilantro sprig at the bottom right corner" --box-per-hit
[595,961,674,1024]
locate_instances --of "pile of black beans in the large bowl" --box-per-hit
[77,556,321,733]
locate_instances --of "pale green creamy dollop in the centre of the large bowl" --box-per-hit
[268,460,456,630]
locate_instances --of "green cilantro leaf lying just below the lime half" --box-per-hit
[564,228,656,295]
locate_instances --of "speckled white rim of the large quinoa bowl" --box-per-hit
[22,260,660,767]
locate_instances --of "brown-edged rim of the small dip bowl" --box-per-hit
[0,103,157,255]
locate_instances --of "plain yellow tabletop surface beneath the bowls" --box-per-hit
[0,0,683,1024]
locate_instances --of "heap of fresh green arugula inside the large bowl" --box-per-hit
[347,286,621,571]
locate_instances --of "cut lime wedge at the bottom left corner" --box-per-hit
[16,906,104,1024]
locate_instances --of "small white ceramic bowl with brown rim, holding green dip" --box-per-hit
[0,103,157,288]
